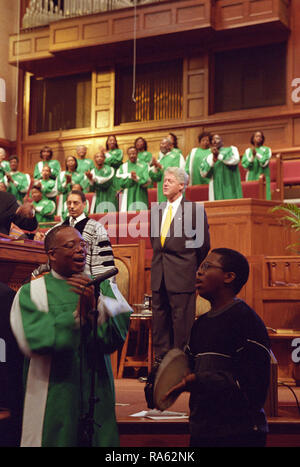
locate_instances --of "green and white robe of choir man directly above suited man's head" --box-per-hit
[149,150,185,203]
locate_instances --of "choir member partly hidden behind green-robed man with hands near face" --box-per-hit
[185,131,211,185]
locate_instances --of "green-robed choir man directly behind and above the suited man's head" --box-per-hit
[149,138,185,203]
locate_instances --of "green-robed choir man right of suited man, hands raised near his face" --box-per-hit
[200,135,243,201]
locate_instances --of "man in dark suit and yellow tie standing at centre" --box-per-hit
[151,167,210,363]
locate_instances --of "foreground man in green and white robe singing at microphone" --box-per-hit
[11,226,132,447]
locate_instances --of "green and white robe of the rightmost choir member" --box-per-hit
[242,146,272,200]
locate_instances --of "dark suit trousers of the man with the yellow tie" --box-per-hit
[152,283,196,358]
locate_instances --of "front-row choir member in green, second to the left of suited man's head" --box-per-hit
[86,148,118,213]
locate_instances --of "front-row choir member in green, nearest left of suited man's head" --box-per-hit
[116,146,150,212]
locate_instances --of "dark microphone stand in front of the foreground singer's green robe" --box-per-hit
[79,283,101,447]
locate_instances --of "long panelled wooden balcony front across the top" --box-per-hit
[9,0,289,74]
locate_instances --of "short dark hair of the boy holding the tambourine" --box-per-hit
[211,248,249,294]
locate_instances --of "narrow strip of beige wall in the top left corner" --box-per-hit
[0,0,19,141]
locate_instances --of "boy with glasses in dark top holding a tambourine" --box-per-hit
[166,248,270,447]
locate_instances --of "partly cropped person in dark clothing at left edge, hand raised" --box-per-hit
[0,191,38,235]
